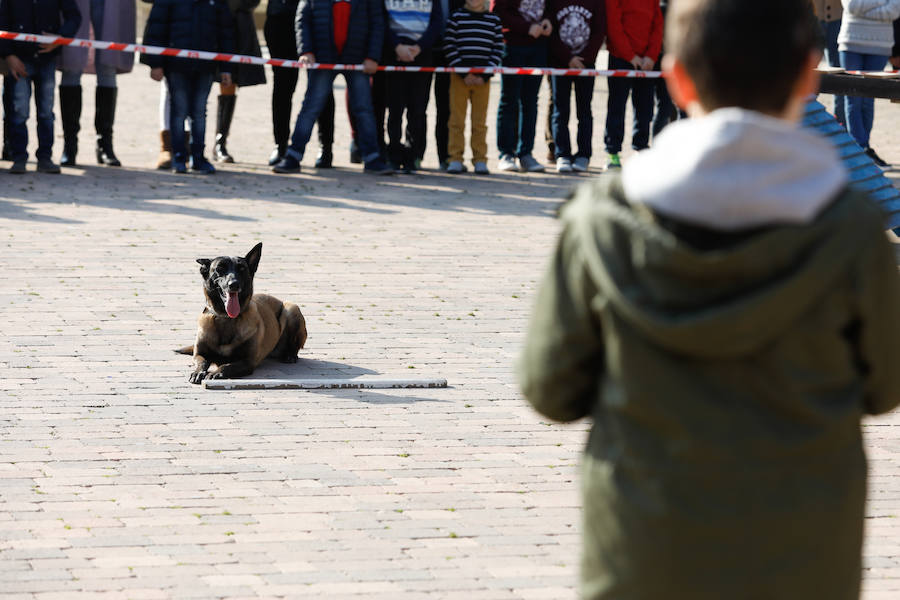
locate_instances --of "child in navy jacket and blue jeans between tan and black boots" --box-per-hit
[141,0,234,175]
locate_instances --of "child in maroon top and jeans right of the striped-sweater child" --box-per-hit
[492,0,553,173]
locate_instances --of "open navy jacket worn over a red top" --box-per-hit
[294,0,384,65]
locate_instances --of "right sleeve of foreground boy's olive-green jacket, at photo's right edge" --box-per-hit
[858,215,900,415]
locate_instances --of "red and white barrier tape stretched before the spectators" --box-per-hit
[0,31,662,79]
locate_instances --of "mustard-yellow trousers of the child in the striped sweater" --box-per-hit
[447,74,491,163]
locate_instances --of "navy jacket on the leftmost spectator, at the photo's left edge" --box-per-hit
[0,0,81,62]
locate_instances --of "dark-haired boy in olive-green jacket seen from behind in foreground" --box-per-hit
[519,0,900,600]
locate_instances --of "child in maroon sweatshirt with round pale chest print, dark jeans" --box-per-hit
[550,0,606,173]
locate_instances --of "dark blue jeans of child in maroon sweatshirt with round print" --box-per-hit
[550,71,594,159]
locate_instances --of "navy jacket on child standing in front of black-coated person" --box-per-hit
[141,0,234,73]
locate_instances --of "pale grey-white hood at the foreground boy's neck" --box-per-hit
[622,108,847,231]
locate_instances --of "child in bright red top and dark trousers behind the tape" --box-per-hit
[603,0,663,169]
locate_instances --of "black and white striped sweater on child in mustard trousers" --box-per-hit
[444,8,503,80]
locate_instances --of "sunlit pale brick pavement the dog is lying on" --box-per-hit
[0,68,900,600]
